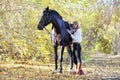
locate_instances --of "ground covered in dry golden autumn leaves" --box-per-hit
[0,54,120,80]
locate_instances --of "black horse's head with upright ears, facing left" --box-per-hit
[38,7,51,30]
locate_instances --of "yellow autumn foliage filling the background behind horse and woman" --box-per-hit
[0,0,119,61]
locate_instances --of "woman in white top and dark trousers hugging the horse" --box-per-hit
[67,21,84,75]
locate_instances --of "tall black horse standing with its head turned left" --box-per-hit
[38,7,73,73]
